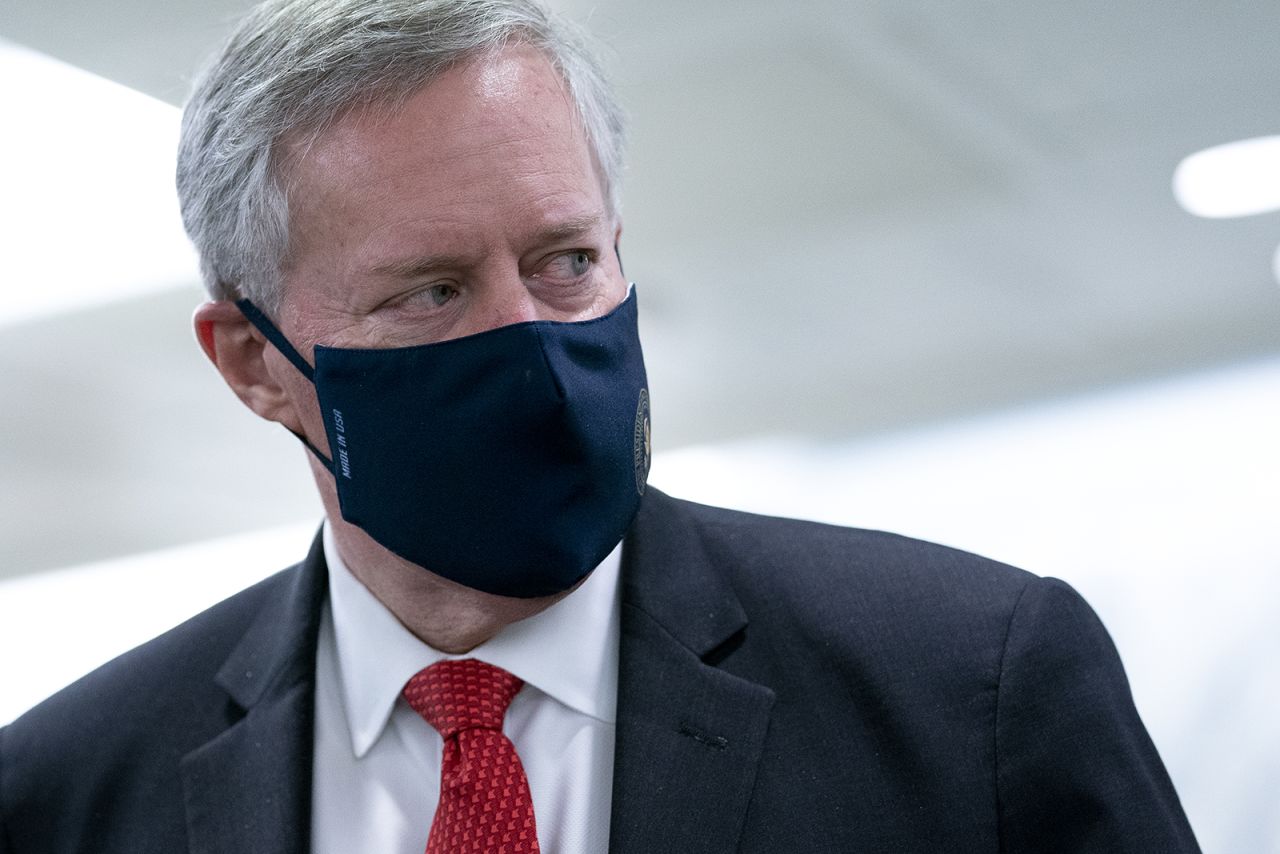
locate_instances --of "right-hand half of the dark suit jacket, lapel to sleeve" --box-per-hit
[614,494,1196,851]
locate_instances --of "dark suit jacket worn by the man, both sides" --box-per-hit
[0,490,1197,854]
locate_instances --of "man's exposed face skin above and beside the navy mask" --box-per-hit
[268,40,626,447]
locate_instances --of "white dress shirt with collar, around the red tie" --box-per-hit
[311,525,621,854]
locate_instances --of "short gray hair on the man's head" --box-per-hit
[178,0,625,314]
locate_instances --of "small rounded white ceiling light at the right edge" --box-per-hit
[1174,136,1280,219]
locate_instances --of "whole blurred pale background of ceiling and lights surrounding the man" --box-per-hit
[0,0,1280,851]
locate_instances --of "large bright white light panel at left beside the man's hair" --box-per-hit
[0,41,198,325]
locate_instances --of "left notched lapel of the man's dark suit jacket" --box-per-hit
[182,536,328,854]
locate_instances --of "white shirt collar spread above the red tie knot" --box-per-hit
[324,522,622,758]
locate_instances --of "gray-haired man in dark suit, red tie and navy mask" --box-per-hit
[0,0,1196,854]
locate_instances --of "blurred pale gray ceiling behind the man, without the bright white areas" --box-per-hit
[0,0,1280,575]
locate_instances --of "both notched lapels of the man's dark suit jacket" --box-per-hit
[182,489,773,854]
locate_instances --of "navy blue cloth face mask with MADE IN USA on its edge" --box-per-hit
[236,288,649,597]
